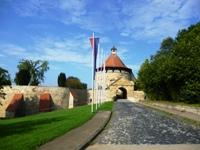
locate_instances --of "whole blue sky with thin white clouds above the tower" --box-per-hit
[0,0,200,86]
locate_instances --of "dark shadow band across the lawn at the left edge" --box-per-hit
[0,117,65,138]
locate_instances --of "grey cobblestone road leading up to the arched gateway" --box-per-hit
[94,100,200,144]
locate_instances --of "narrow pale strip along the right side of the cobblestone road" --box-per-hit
[138,102,200,122]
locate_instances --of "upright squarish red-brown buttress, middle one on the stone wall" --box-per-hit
[39,93,52,112]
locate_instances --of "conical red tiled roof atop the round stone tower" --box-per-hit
[106,53,127,68]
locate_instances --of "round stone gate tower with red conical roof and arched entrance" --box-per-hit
[96,47,135,100]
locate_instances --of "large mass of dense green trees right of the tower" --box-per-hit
[137,23,200,103]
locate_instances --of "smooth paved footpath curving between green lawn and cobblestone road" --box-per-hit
[39,111,111,150]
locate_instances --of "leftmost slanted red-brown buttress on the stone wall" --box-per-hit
[6,93,24,112]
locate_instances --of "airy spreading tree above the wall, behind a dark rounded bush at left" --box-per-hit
[17,60,49,85]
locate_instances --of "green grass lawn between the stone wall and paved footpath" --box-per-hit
[0,102,112,150]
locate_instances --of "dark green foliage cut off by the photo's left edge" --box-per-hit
[0,67,11,100]
